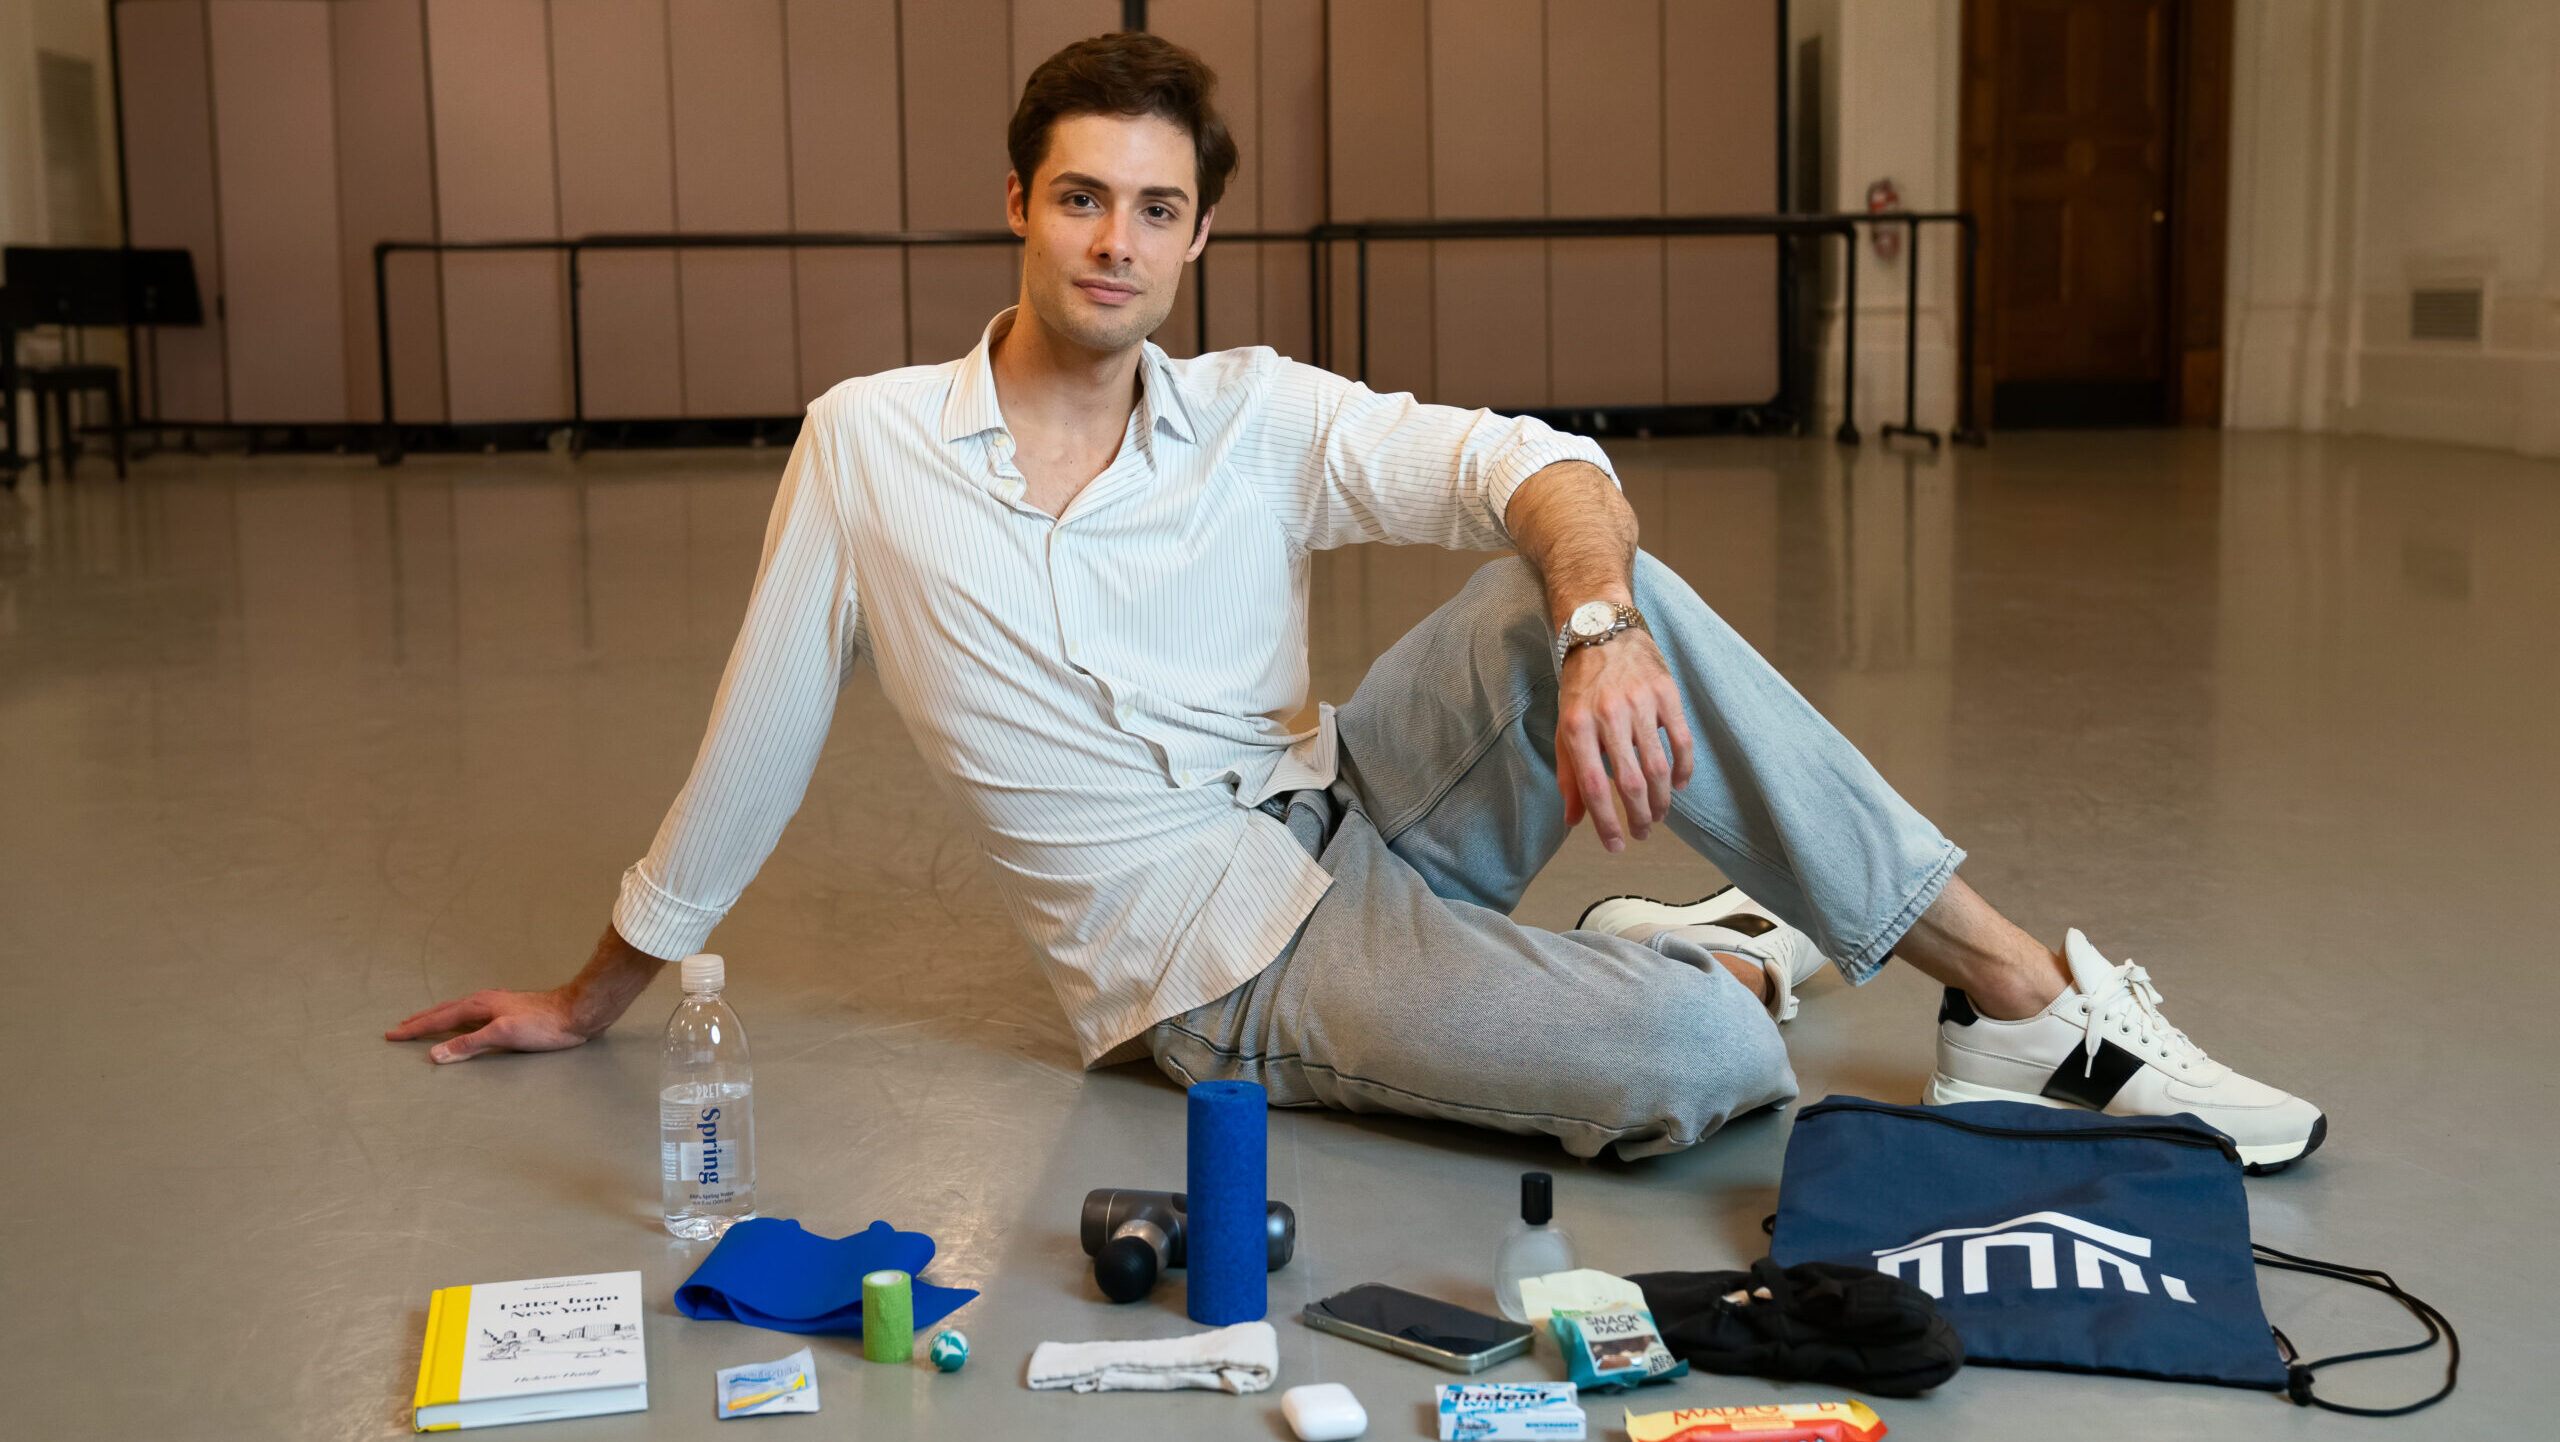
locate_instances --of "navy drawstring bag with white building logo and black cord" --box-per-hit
[1769,1096,2460,1416]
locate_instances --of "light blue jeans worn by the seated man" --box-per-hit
[1147,553,1964,1158]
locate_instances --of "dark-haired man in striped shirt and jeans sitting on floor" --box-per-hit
[389,33,2327,1168]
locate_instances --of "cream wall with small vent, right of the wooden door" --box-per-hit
[2225,0,2560,456]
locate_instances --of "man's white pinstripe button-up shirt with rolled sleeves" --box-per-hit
[614,310,1608,1065]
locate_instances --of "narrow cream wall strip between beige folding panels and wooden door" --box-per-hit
[1787,0,1964,435]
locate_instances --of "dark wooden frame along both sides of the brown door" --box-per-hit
[1958,0,2232,425]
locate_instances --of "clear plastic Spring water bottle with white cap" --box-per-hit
[658,953,755,1240]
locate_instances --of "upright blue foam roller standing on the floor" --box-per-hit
[1183,1081,1270,1327]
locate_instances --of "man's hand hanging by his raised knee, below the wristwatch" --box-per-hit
[1556,630,1695,850]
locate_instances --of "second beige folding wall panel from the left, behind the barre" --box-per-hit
[207,0,346,423]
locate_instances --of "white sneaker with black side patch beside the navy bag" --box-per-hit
[1923,930,2330,1176]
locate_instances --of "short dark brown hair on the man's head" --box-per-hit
[1004,31,1236,215]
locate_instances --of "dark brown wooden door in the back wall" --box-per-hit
[1964,0,2227,425]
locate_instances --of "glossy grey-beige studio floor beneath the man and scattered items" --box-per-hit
[0,422,2560,1442]
